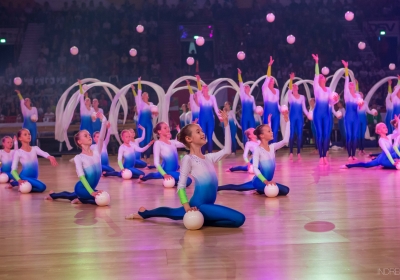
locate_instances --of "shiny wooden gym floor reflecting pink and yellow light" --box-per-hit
[0,150,400,280]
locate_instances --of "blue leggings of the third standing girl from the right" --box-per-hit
[313,104,332,157]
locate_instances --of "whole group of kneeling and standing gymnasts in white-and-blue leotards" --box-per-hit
[0,55,400,230]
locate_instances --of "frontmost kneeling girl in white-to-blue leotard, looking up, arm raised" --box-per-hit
[126,109,245,227]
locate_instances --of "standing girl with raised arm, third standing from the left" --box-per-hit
[131,77,157,163]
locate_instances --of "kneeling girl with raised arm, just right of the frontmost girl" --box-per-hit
[218,114,290,195]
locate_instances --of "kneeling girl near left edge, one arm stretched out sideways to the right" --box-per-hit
[11,128,57,192]
